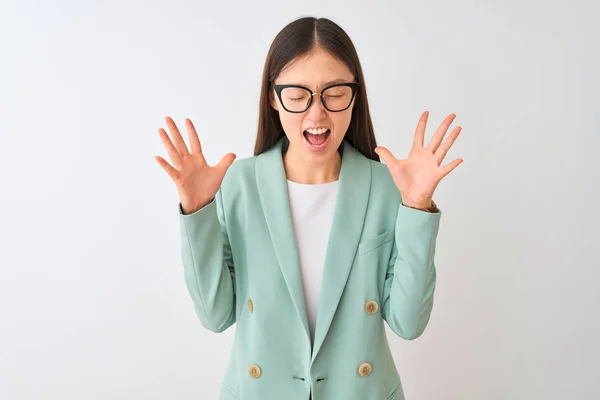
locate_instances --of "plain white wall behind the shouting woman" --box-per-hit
[0,0,600,400]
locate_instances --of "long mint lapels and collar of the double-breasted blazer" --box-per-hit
[256,136,371,363]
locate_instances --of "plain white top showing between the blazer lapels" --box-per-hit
[287,180,339,343]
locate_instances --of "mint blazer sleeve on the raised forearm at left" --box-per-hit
[178,189,235,333]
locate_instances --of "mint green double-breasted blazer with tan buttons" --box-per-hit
[179,136,440,400]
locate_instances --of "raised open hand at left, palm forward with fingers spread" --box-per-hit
[154,117,237,214]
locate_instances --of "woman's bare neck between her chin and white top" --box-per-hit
[283,141,342,185]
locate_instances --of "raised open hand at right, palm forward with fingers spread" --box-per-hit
[375,111,463,210]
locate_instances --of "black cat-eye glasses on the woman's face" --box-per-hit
[273,82,359,113]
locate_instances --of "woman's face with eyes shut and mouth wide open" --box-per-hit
[271,49,354,160]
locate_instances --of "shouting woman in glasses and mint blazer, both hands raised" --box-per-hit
[156,18,462,400]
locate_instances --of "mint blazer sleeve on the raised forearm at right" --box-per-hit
[382,204,441,340]
